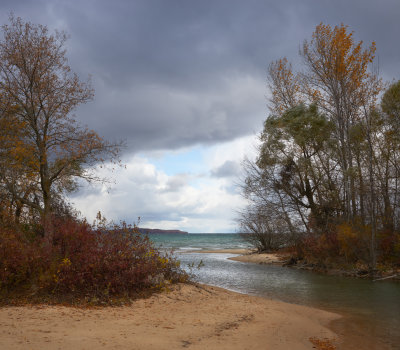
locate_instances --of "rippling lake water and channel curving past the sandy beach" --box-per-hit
[150,234,400,349]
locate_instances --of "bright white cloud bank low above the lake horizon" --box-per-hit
[71,139,252,232]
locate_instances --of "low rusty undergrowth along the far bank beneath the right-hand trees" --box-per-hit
[242,209,400,272]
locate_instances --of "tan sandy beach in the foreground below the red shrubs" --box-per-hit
[0,285,340,350]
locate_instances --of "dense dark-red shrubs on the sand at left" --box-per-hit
[0,218,187,303]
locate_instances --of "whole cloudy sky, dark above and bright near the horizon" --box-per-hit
[0,0,400,233]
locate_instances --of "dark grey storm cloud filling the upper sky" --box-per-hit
[0,0,400,151]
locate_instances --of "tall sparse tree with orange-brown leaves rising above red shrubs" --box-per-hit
[0,16,119,230]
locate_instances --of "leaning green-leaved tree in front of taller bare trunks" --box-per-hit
[257,105,340,231]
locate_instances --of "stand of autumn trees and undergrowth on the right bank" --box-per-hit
[239,23,400,274]
